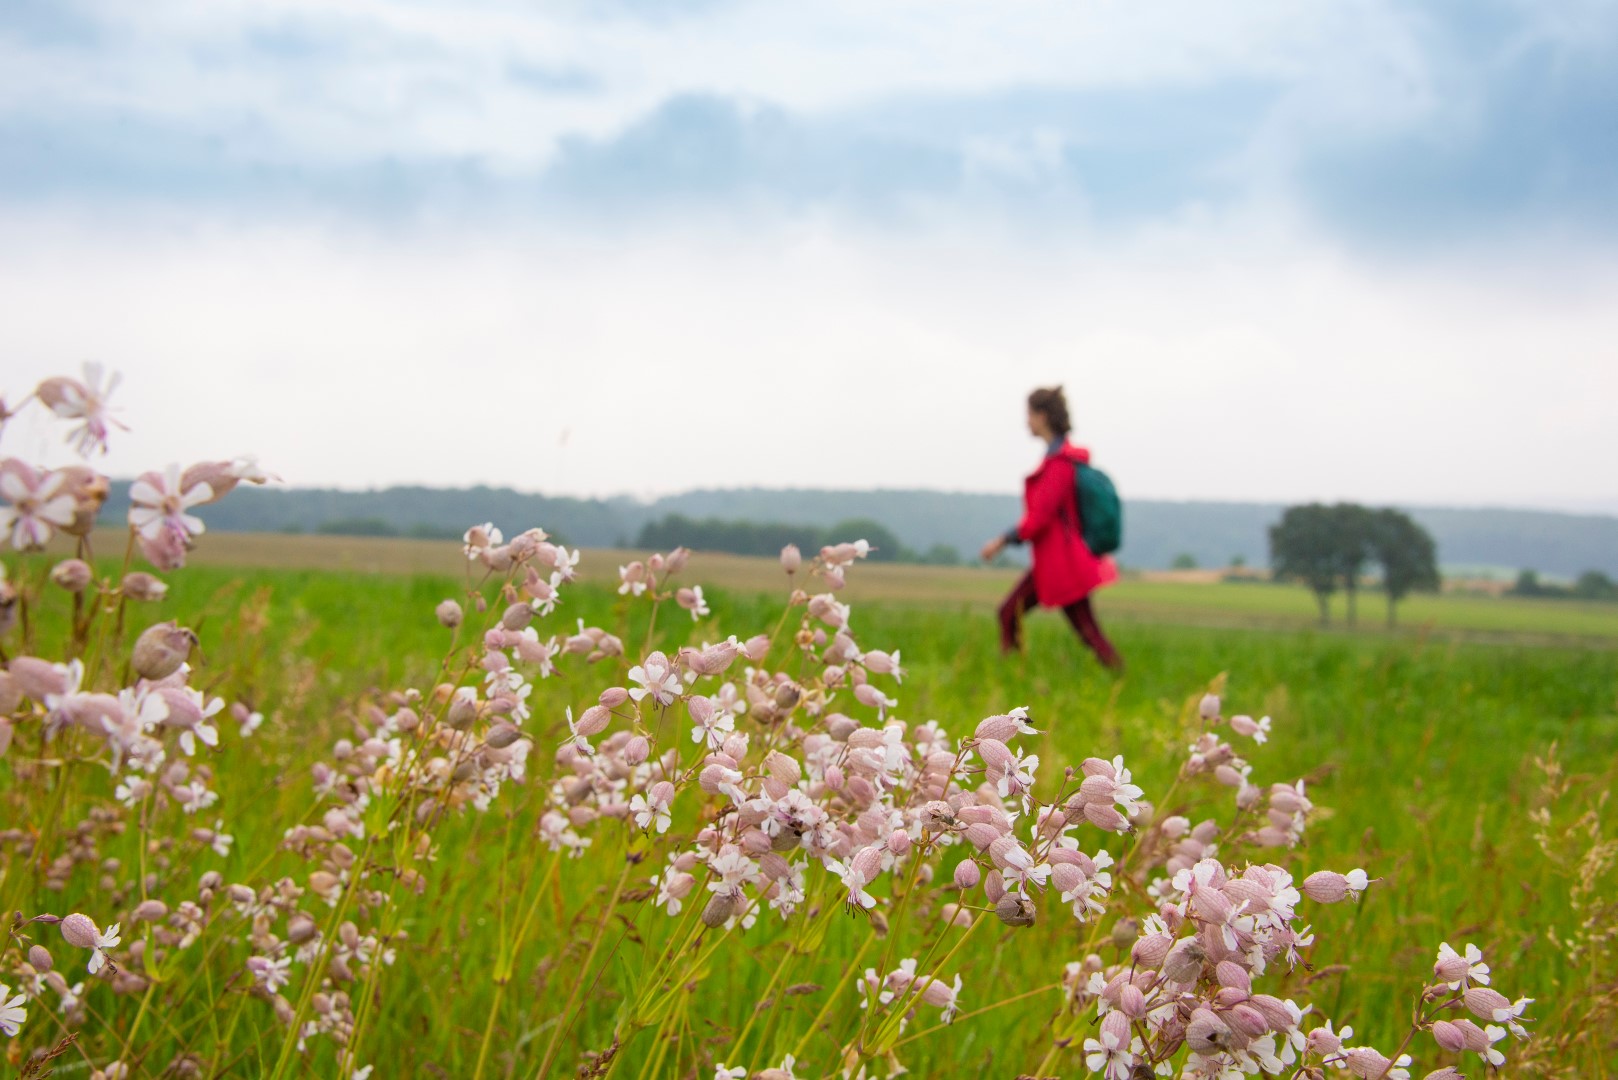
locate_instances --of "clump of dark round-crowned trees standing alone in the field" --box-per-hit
[1270,502,1442,627]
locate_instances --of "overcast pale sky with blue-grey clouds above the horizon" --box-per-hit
[0,0,1618,512]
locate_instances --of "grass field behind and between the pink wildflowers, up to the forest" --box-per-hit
[9,536,1618,1080]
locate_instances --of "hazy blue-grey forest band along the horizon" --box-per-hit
[104,483,1618,581]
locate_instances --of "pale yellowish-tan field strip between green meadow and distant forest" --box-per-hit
[69,529,1618,648]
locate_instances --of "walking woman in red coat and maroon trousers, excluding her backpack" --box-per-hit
[979,387,1123,672]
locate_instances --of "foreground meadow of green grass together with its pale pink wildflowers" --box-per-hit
[0,369,1618,1080]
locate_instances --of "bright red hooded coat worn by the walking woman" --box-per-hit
[1016,442,1118,607]
